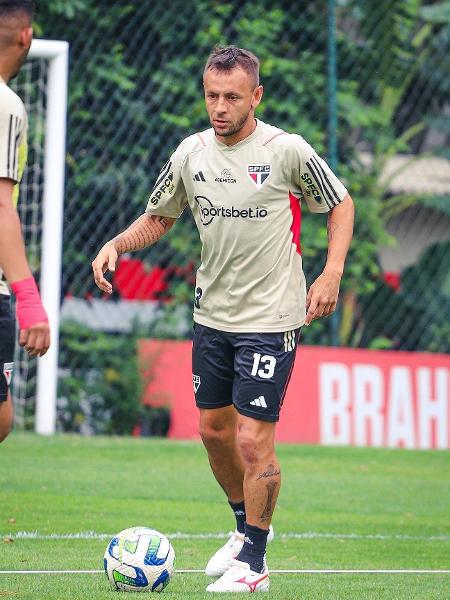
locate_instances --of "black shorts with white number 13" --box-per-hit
[192,323,300,421]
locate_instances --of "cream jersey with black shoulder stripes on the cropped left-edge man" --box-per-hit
[0,78,28,295]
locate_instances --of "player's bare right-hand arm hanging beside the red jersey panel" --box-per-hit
[305,194,355,325]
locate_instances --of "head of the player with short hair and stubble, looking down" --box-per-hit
[203,46,263,141]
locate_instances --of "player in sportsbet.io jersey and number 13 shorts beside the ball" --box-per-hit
[93,46,353,592]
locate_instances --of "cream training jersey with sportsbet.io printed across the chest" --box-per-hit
[146,120,347,333]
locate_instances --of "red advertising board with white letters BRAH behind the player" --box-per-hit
[140,340,450,448]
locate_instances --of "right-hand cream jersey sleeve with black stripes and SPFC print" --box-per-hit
[293,136,347,212]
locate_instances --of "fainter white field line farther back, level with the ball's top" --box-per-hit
[4,531,450,542]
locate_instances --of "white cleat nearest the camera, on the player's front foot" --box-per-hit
[206,559,269,593]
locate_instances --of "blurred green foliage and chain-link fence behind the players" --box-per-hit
[14,0,450,435]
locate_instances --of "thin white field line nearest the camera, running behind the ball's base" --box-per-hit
[0,569,450,575]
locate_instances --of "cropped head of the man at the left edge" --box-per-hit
[0,0,34,79]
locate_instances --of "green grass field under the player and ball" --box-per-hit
[0,434,450,600]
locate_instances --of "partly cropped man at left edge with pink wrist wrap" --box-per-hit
[0,0,50,442]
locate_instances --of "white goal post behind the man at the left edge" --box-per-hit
[29,39,69,435]
